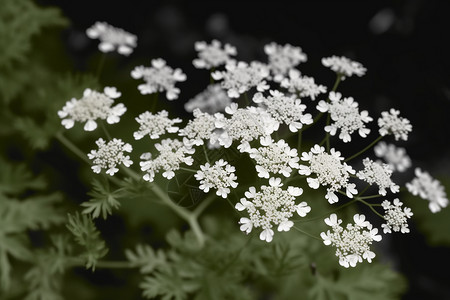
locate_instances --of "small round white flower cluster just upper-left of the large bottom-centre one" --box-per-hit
[194,159,238,198]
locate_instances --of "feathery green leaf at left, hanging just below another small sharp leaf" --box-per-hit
[66,212,108,270]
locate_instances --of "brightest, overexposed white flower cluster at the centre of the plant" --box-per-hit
[215,103,279,152]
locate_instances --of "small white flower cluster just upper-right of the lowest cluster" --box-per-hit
[381,198,413,233]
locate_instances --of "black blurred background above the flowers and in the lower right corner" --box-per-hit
[38,0,450,299]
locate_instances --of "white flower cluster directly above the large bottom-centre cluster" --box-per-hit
[248,136,300,178]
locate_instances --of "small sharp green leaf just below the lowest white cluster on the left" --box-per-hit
[81,178,123,219]
